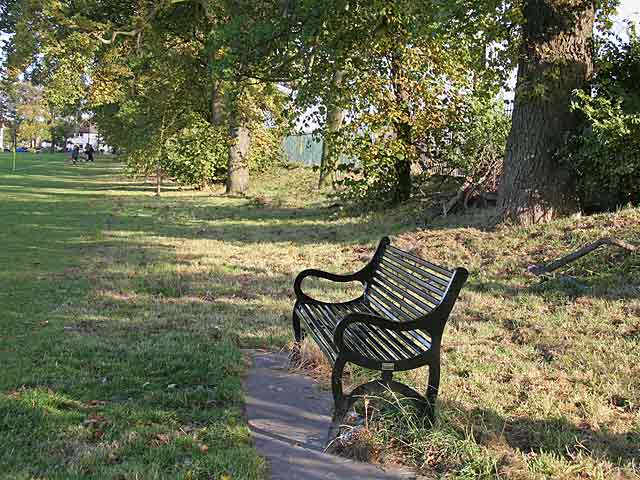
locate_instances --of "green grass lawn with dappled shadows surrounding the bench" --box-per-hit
[0,154,640,479]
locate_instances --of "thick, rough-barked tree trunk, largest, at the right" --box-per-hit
[498,0,594,224]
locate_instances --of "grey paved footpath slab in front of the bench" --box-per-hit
[245,350,419,480]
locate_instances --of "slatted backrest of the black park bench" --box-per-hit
[365,237,468,322]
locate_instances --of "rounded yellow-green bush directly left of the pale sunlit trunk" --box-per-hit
[161,116,228,188]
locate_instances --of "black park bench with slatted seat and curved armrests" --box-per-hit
[293,237,469,424]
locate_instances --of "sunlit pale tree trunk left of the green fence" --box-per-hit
[227,110,251,193]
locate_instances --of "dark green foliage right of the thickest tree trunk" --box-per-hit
[559,28,640,212]
